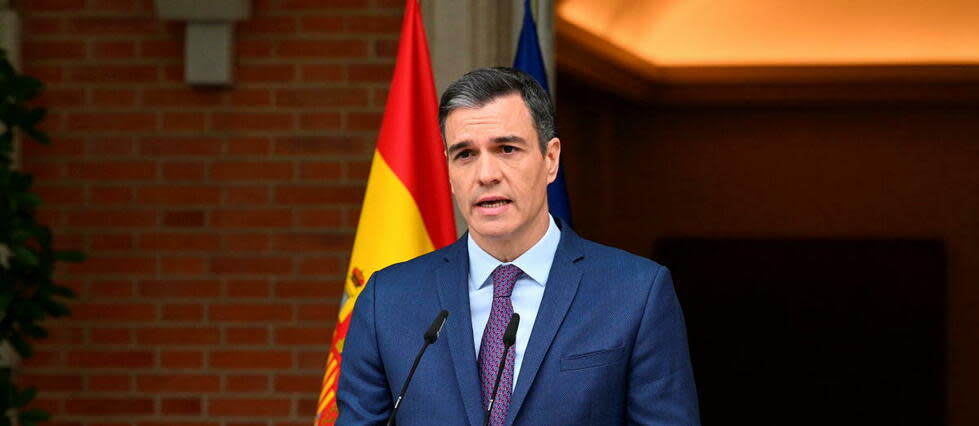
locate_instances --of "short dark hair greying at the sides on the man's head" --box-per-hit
[439,67,554,154]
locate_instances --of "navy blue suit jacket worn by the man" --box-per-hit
[336,224,699,426]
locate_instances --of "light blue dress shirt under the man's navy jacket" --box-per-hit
[468,215,561,387]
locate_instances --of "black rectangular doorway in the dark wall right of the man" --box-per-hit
[654,238,946,426]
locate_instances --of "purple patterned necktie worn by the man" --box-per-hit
[479,265,523,426]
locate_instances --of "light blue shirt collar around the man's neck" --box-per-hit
[467,215,561,291]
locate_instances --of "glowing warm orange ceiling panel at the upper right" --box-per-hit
[558,0,979,66]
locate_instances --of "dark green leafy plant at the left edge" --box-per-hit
[0,49,84,426]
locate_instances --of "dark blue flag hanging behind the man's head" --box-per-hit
[513,0,571,226]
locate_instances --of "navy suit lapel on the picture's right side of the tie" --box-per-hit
[506,226,581,424]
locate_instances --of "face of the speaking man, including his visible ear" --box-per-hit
[445,93,561,247]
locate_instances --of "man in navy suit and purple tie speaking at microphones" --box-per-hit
[337,68,699,425]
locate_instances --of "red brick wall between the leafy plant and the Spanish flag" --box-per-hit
[15,0,404,426]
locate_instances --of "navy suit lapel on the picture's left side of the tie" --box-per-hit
[433,237,483,425]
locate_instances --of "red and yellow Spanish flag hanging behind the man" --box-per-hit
[315,0,456,426]
